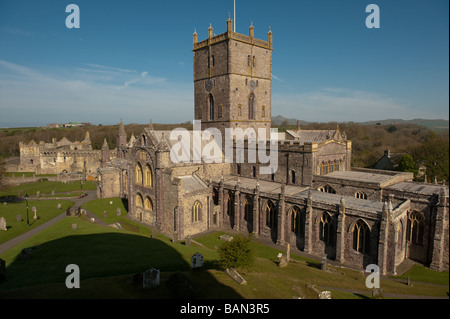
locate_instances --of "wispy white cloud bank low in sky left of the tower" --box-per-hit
[0,60,193,127]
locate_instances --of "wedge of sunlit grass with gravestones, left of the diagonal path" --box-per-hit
[0,200,74,244]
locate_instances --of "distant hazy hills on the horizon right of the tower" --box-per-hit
[272,115,449,132]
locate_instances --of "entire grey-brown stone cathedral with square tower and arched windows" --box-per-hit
[97,19,449,274]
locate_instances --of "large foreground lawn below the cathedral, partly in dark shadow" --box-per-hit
[0,210,449,299]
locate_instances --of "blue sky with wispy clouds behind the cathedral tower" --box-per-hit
[0,0,449,127]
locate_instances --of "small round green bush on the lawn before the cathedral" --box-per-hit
[218,236,255,270]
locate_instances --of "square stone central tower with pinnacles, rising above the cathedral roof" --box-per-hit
[193,19,273,138]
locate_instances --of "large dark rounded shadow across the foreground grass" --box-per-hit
[0,233,242,299]
